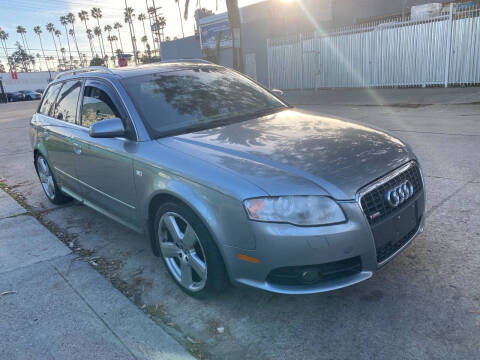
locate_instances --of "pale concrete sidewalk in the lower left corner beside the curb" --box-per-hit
[0,190,193,360]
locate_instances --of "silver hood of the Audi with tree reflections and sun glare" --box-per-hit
[164,110,413,200]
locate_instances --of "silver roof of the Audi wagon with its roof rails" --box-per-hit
[54,60,221,82]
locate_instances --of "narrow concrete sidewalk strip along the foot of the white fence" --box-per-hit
[284,87,480,106]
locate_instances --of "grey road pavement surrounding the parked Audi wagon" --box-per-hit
[0,102,480,360]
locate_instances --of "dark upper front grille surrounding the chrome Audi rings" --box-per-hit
[360,163,423,225]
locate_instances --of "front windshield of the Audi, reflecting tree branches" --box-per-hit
[122,65,286,137]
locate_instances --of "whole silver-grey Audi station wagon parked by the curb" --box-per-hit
[30,61,425,297]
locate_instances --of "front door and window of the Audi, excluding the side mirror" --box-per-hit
[77,80,137,225]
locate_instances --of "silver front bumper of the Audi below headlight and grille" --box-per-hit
[223,190,425,294]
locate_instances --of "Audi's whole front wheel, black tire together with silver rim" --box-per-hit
[152,201,227,299]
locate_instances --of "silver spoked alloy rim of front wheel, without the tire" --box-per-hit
[158,212,207,292]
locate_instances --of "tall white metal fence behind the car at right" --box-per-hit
[267,4,480,89]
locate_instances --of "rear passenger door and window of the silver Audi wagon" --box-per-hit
[43,80,82,193]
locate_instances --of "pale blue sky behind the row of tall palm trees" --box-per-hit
[0,0,261,64]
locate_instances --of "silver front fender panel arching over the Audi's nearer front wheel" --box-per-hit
[134,141,265,252]
